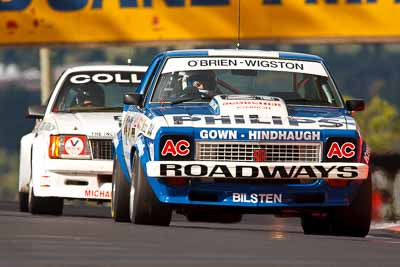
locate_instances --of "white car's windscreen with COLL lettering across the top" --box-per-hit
[52,71,143,112]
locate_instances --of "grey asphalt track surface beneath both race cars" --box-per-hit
[0,202,400,267]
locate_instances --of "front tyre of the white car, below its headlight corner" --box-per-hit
[28,180,64,216]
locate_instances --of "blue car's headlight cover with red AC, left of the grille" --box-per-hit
[160,135,194,160]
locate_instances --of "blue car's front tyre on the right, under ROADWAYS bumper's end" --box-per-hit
[332,175,372,237]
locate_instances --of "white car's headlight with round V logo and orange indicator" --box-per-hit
[49,135,91,159]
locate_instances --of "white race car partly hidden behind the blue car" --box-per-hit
[19,66,146,215]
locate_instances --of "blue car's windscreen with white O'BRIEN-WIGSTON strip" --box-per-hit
[152,57,342,107]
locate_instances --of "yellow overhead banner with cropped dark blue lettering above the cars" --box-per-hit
[0,0,400,45]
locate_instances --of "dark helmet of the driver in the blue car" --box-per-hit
[187,70,217,95]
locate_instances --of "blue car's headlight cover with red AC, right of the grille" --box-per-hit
[324,137,359,162]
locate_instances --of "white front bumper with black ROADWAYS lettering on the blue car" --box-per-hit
[146,161,369,180]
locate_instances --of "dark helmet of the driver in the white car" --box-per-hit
[74,83,104,107]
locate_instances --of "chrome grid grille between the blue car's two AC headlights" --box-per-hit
[196,142,321,162]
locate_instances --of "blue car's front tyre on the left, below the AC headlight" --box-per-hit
[129,153,172,226]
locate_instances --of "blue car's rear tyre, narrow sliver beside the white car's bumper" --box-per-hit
[111,155,130,222]
